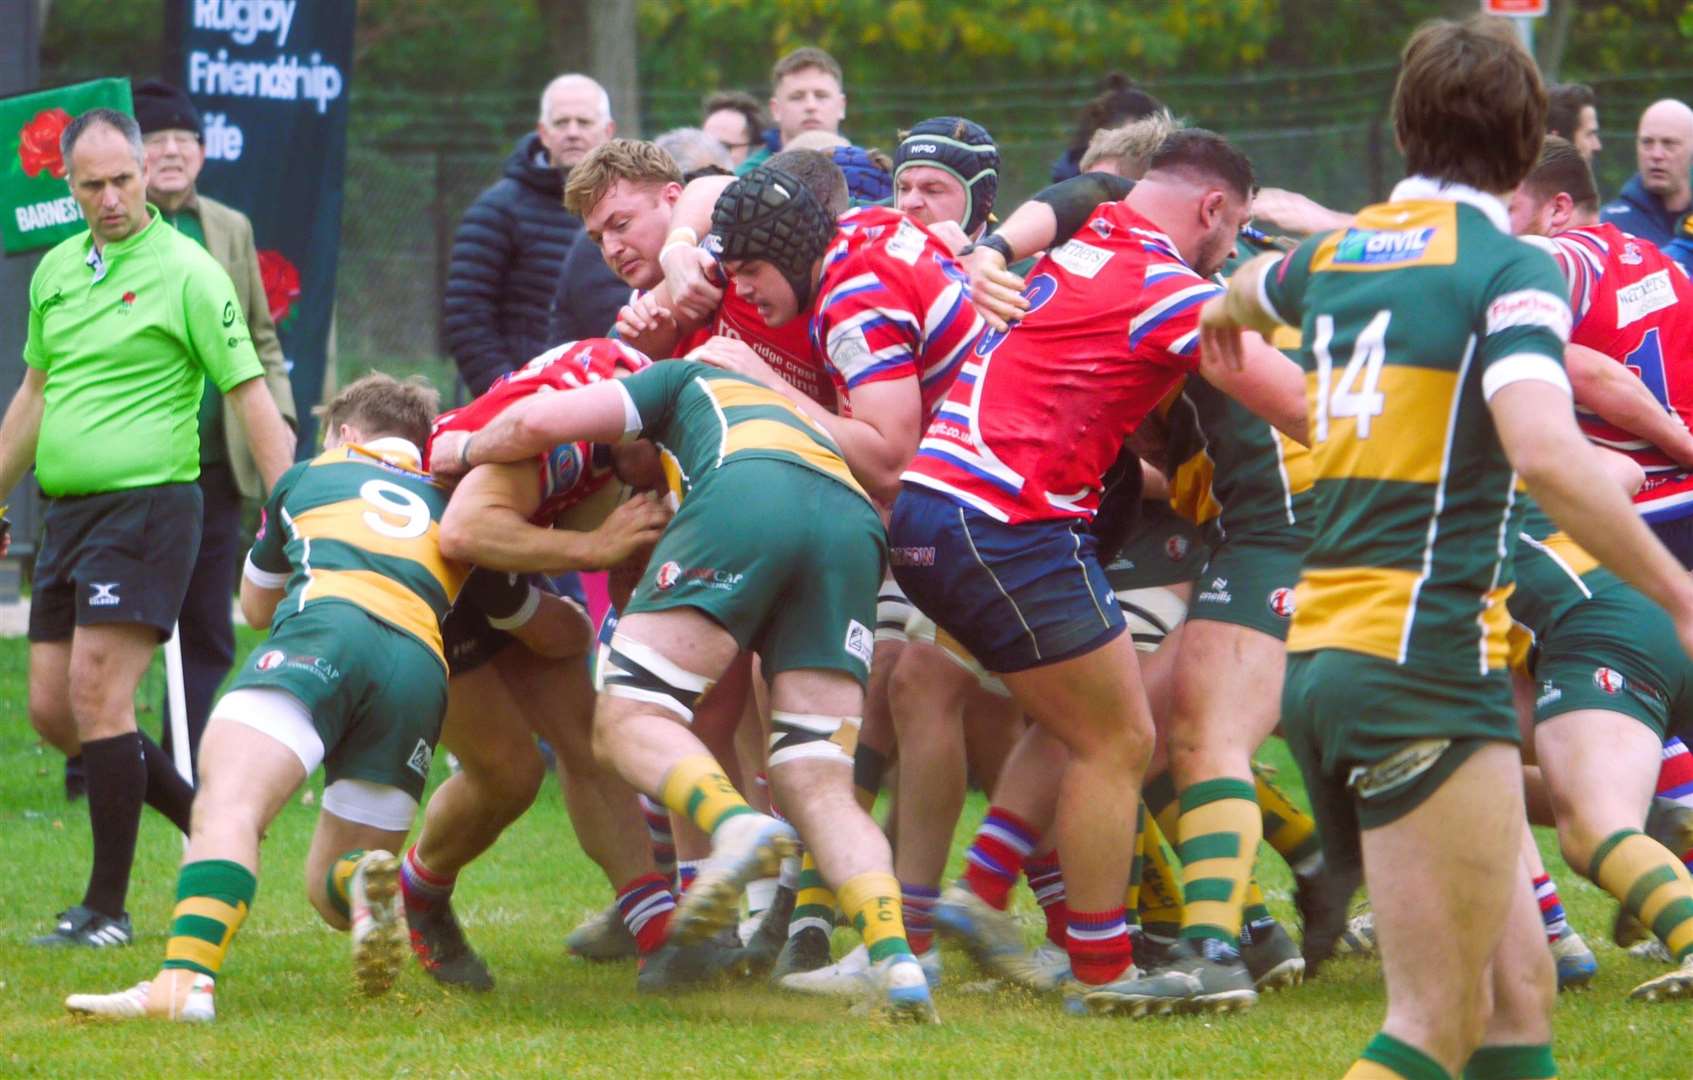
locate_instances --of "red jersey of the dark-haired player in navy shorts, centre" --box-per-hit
[901,203,1222,525]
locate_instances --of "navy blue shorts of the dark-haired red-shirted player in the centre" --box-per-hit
[887,484,1124,674]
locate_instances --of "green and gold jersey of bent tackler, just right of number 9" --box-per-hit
[616,361,870,501]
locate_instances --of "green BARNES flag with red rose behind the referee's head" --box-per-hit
[0,80,132,256]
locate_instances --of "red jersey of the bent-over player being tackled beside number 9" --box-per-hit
[423,337,652,525]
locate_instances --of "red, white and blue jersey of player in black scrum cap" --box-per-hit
[811,207,985,420]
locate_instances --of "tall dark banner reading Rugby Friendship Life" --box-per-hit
[166,0,356,457]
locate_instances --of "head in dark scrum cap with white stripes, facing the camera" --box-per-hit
[894,117,999,242]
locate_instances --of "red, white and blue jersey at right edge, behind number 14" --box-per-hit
[1549,223,1693,521]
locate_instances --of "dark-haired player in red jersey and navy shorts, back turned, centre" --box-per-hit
[889,129,1304,1014]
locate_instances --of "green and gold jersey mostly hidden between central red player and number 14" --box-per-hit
[1168,376,1314,547]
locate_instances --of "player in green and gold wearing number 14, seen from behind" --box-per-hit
[1202,17,1693,1077]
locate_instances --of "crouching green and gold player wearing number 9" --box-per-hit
[64,374,469,1021]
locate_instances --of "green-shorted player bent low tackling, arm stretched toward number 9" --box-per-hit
[432,357,936,1021]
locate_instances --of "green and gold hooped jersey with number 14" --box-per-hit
[1260,178,1569,677]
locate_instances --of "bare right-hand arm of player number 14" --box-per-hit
[1488,379,1693,653]
